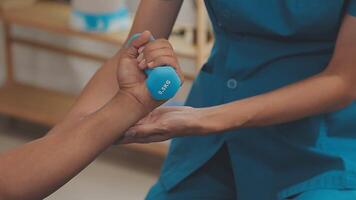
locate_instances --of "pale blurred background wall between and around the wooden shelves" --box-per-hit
[0,0,195,101]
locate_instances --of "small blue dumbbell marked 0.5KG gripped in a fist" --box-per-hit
[127,33,181,100]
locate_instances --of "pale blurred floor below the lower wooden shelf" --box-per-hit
[0,116,162,200]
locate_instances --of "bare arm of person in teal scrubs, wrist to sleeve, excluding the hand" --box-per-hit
[199,16,356,128]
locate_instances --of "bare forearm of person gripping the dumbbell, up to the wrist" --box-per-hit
[0,92,145,200]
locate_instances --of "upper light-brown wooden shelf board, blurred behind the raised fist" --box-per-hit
[4,1,209,59]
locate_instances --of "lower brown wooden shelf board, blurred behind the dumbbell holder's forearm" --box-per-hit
[0,83,168,157]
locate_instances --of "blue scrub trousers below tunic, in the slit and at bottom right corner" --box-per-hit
[146,145,356,200]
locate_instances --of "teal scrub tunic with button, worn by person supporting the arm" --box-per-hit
[159,0,356,200]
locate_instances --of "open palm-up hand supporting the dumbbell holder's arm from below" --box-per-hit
[120,106,219,144]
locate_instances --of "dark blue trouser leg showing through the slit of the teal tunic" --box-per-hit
[146,146,236,200]
